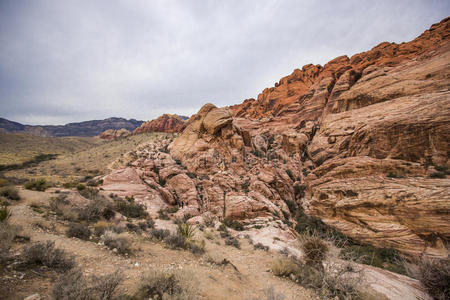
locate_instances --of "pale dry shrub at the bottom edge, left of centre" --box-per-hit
[136,269,196,300]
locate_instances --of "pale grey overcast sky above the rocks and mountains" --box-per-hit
[0,0,450,125]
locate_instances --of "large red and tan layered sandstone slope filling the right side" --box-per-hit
[104,18,450,257]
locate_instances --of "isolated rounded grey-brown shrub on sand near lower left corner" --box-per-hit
[22,241,75,271]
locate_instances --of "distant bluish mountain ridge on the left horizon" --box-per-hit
[0,117,144,137]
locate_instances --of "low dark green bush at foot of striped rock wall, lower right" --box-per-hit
[339,244,406,274]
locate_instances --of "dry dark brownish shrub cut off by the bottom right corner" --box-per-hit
[406,256,450,300]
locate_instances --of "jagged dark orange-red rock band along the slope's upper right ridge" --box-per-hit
[230,18,450,120]
